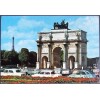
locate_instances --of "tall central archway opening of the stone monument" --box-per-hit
[53,47,62,68]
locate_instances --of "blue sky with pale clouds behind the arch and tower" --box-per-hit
[1,16,99,58]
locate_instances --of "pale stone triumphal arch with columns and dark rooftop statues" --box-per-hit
[36,20,87,69]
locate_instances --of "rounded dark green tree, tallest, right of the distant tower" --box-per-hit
[18,48,29,65]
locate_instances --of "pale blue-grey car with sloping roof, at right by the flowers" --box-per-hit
[68,70,95,78]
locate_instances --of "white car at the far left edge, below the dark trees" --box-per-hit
[1,68,25,76]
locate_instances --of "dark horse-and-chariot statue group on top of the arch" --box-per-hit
[54,20,70,30]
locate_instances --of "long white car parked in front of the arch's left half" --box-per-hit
[31,69,61,77]
